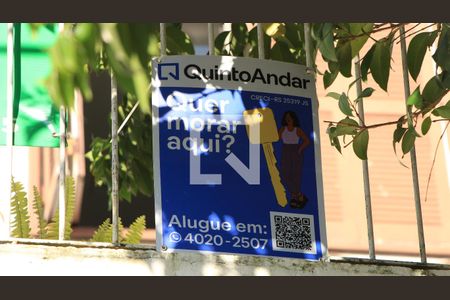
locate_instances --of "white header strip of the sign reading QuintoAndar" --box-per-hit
[152,55,315,98]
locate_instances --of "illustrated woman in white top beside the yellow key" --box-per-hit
[278,111,311,208]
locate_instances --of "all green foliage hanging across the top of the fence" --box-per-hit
[39,23,450,201]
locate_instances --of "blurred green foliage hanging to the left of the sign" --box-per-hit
[61,23,194,202]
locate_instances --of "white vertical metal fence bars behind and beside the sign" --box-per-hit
[0,23,442,264]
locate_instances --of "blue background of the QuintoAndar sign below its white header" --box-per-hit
[158,87,324,260]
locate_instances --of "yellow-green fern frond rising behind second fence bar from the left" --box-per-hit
[47,176,75,240]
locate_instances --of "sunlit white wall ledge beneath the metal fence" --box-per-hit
[0,243,450,276]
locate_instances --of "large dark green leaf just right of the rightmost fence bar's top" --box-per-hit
[406,31,437,81]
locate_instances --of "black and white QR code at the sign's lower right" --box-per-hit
[270,211,317,254]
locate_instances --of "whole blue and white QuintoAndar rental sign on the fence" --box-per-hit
[152,56,327,260]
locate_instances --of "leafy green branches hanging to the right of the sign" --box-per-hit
[319,23,450,159]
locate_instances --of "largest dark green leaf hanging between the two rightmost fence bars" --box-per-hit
[370,39,391,91]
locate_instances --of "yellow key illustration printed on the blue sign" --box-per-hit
[244,107,288,207]
